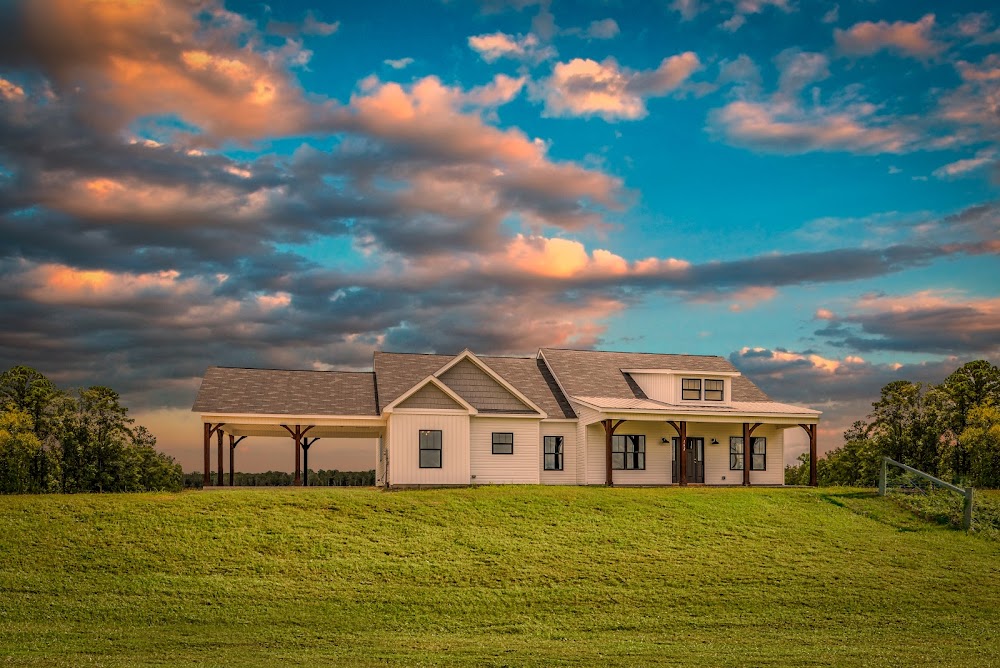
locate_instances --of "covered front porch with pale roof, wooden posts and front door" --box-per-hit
[575,398,819,486]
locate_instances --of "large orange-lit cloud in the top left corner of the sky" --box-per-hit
[12,0,315,140]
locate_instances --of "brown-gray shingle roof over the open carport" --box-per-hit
[191,366,378,416]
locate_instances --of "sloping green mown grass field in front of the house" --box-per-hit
[0,487,1000,667]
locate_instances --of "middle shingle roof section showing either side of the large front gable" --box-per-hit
[375,351,576,418]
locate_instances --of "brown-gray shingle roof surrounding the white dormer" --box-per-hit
[542,348,771,401]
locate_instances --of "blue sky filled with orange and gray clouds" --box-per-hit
[0,0,1000,468]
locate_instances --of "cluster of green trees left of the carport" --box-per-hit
[0,365,183,494]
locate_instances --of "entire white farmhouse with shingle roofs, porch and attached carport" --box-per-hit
[192,348,820,487]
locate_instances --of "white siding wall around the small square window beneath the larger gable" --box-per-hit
[469,416,539,485]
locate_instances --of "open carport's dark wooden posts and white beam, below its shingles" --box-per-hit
[201,413,385,487]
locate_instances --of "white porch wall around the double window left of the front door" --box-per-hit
[586,420,677,485]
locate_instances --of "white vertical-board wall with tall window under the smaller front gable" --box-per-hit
[387,410,471,486]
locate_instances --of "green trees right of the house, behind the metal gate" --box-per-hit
[785,360,1000,488]
